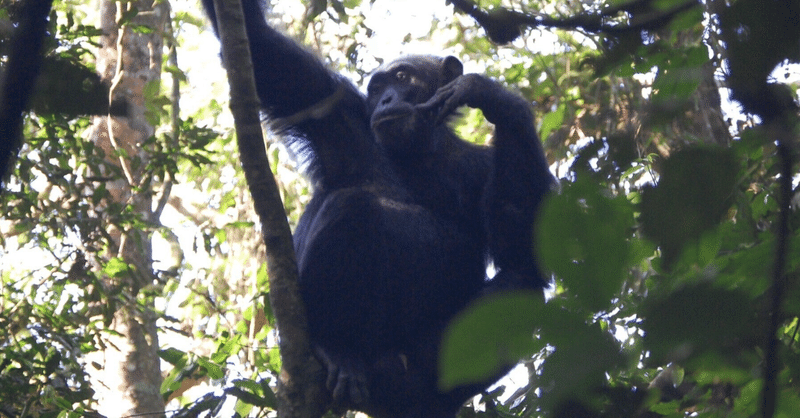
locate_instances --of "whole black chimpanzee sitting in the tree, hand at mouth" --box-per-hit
[203,0,553,418]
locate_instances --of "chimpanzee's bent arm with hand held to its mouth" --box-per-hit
[419,74,554,289]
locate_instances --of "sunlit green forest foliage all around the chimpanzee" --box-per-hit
[0,0,800,417]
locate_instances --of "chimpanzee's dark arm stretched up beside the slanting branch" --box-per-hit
[198,0,375,186]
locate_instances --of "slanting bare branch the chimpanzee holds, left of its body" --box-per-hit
[209,0,327,418]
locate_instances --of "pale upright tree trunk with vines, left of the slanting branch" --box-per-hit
[89,0,169,417]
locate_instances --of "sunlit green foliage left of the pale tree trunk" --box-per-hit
[0,4,123,416]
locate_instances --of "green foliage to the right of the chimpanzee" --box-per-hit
[443,0,800,417]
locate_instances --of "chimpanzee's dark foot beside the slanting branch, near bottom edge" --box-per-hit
[315,347,369,405]
